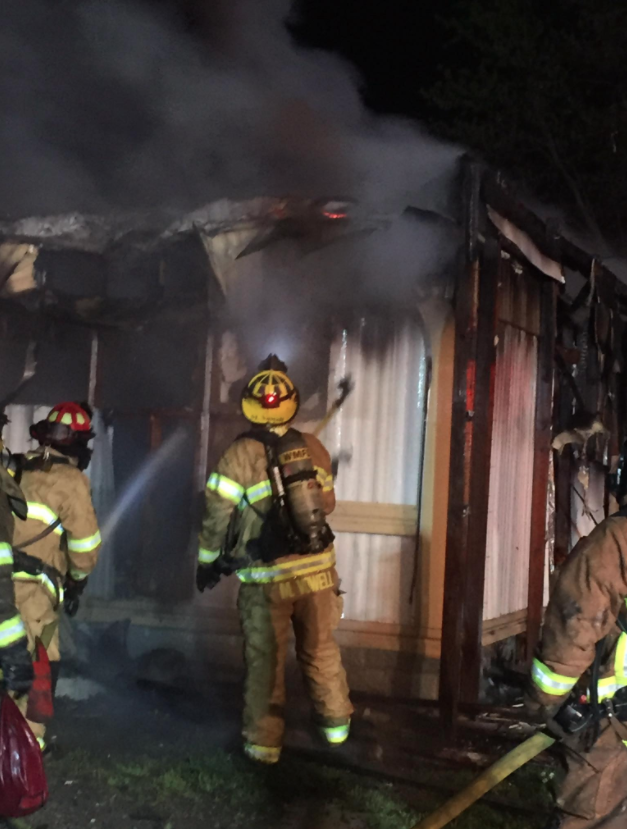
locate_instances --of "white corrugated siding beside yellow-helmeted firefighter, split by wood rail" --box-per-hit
[322,318,426,623]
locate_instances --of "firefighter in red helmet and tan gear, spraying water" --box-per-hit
[13,403,101,748]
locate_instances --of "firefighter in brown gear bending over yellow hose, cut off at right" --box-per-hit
[527,436,627,829]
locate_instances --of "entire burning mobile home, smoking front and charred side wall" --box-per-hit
[0,157,624,720]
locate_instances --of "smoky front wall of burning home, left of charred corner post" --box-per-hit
[2,186,459,693]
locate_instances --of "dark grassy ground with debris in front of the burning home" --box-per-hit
[7,689,555,829]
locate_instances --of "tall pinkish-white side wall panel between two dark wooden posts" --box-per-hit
[483,325,538,620]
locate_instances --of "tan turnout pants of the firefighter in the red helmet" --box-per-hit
[15,582,61,749]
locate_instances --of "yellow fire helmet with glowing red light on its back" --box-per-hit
[242,355,300,426]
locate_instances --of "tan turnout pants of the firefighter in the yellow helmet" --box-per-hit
[238,570,353,763]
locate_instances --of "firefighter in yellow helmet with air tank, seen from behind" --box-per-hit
[197,355,353,763]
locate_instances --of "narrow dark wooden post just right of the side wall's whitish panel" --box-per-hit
[526,279,557,660]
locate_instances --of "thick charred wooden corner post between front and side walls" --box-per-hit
[440,160,500,737]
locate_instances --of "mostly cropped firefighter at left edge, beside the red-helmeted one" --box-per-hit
[0,460,33,695]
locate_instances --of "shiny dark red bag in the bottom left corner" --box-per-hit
[0,694,48,817]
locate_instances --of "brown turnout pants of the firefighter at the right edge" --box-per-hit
[557,721,627,829]
